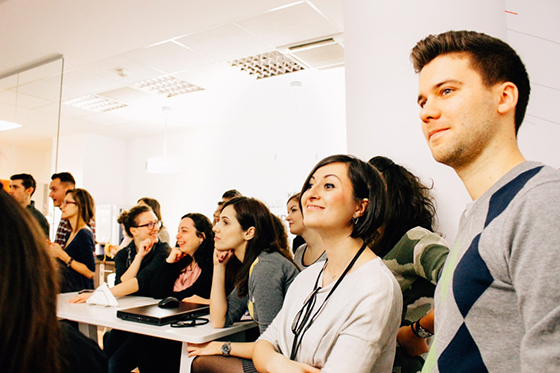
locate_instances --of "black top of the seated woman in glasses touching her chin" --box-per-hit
[115,240,170,296]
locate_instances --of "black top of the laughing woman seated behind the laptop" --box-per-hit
[152,255,214,300]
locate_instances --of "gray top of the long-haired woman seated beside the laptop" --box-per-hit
[224,251,299,334]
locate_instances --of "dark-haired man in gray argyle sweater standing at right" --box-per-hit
[411,31,560,373]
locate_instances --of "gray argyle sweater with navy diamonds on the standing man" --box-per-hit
[423,162,560,373]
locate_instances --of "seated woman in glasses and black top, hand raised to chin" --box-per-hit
[70,202,170,303]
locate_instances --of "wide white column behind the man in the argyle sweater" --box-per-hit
[344,0,506,238]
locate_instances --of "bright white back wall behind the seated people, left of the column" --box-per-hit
[125,69,346,232]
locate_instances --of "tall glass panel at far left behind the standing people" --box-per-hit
[0,56,64,232]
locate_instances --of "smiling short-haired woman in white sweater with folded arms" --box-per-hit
[253,155,402,373]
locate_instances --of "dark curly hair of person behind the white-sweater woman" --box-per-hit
[369,156,436,257]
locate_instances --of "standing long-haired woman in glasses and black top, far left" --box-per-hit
[49,189,95,293]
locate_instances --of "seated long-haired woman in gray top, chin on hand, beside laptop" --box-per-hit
[189,197,299,372]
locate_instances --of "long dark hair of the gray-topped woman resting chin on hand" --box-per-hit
[222,197,295,296]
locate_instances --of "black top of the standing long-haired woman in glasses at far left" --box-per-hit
[59,228,95,293]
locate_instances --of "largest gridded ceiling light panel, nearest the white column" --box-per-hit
[230,51,304,79]
